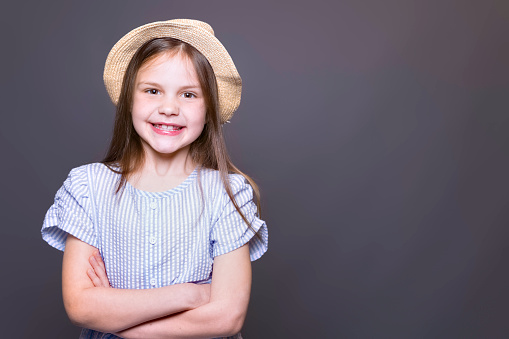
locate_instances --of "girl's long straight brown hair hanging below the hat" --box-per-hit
[102,38,260,227]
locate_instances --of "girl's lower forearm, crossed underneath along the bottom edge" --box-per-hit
[117,301,247,339]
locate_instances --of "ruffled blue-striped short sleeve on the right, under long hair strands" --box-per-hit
[211,174,268,261]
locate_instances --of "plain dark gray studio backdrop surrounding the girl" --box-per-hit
[0,0,509,339]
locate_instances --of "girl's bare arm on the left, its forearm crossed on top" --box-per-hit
[62,234,209,332]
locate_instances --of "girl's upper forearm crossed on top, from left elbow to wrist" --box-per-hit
[64,284,200,332]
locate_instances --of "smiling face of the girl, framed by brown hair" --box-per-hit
[132,53,206,162]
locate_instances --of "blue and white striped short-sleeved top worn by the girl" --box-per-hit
[41,163,268,338]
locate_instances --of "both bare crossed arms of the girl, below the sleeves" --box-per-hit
[62,235,251,338]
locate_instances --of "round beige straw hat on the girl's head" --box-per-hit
[104,19,242,123]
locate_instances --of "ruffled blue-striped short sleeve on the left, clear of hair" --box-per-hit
[41,166,97,251]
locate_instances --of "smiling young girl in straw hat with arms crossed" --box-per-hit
[42,20,268,338]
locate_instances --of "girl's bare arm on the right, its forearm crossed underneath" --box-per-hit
[114,244,251,338]
